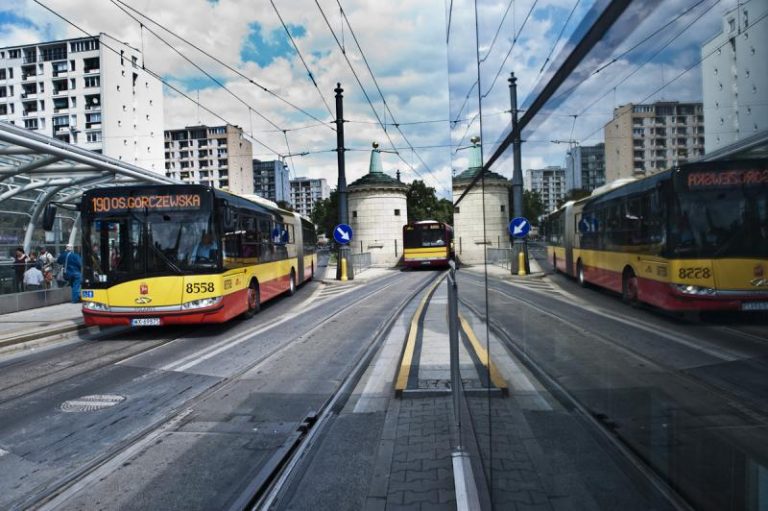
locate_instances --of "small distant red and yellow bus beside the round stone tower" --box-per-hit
[403,220,453,268]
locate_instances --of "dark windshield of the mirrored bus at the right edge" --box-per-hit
[669,189,768,258]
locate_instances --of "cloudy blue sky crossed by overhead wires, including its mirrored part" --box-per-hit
[0,0,748,196]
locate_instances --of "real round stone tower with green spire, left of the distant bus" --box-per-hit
[347,147,408,266]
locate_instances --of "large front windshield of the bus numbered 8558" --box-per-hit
[83,211,219,287]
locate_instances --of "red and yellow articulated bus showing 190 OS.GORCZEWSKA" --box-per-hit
[80,185,317,326]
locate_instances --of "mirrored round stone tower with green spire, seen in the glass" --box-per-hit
[453,147,512,264]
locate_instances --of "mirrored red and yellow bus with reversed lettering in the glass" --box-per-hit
[545,159,768,311]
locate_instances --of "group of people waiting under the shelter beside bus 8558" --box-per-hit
[13,245,82,303]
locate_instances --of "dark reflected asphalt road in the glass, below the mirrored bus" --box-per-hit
[459,255,768,511]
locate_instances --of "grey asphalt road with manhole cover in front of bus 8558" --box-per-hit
[0,274,429,509]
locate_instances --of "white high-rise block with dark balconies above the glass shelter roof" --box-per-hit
[0,34,163,172]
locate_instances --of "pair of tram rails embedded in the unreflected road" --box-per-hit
[24,275,440,509]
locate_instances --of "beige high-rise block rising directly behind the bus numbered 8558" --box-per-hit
[165,124,253,194]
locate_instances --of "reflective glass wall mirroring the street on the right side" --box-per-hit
[446,0,768,510]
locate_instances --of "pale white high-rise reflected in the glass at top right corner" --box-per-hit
[701,0,768,153]
